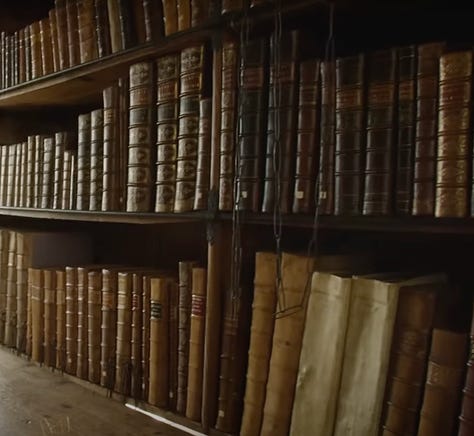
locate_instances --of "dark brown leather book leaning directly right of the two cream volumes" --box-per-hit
[380,275,446,436]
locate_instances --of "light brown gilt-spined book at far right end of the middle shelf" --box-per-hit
[435,51,472,217]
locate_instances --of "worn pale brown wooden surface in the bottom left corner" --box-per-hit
[0,348,187,436]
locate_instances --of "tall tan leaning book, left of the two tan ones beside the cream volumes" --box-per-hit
[240,252,277,436]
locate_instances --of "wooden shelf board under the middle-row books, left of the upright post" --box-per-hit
[0,207,208,224]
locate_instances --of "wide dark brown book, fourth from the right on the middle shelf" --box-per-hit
[363,48,397,215]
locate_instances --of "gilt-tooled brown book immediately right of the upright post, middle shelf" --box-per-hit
[219,41,239,211]
